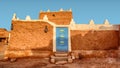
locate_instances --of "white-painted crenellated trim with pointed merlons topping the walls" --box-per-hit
[12,9,119,30]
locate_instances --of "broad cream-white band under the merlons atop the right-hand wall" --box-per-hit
[70,24,119,30]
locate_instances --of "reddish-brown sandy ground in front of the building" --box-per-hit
[0,58,120,68]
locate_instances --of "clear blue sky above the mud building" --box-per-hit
[0,0,120,30]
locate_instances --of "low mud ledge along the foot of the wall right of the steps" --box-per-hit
[72,50,118,59]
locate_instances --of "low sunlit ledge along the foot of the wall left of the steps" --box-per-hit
[4,50,51,58]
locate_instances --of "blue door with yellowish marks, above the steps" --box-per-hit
[56,27,68,52]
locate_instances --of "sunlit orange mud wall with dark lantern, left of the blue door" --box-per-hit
[8,20,53,51]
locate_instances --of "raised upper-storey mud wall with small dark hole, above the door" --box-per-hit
[39,11,72,25]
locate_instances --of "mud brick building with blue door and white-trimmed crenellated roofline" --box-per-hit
[0,10,120,61]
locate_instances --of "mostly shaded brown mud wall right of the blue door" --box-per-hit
[71,30,119,50]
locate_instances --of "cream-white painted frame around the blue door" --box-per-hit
[53,25,71,52]
